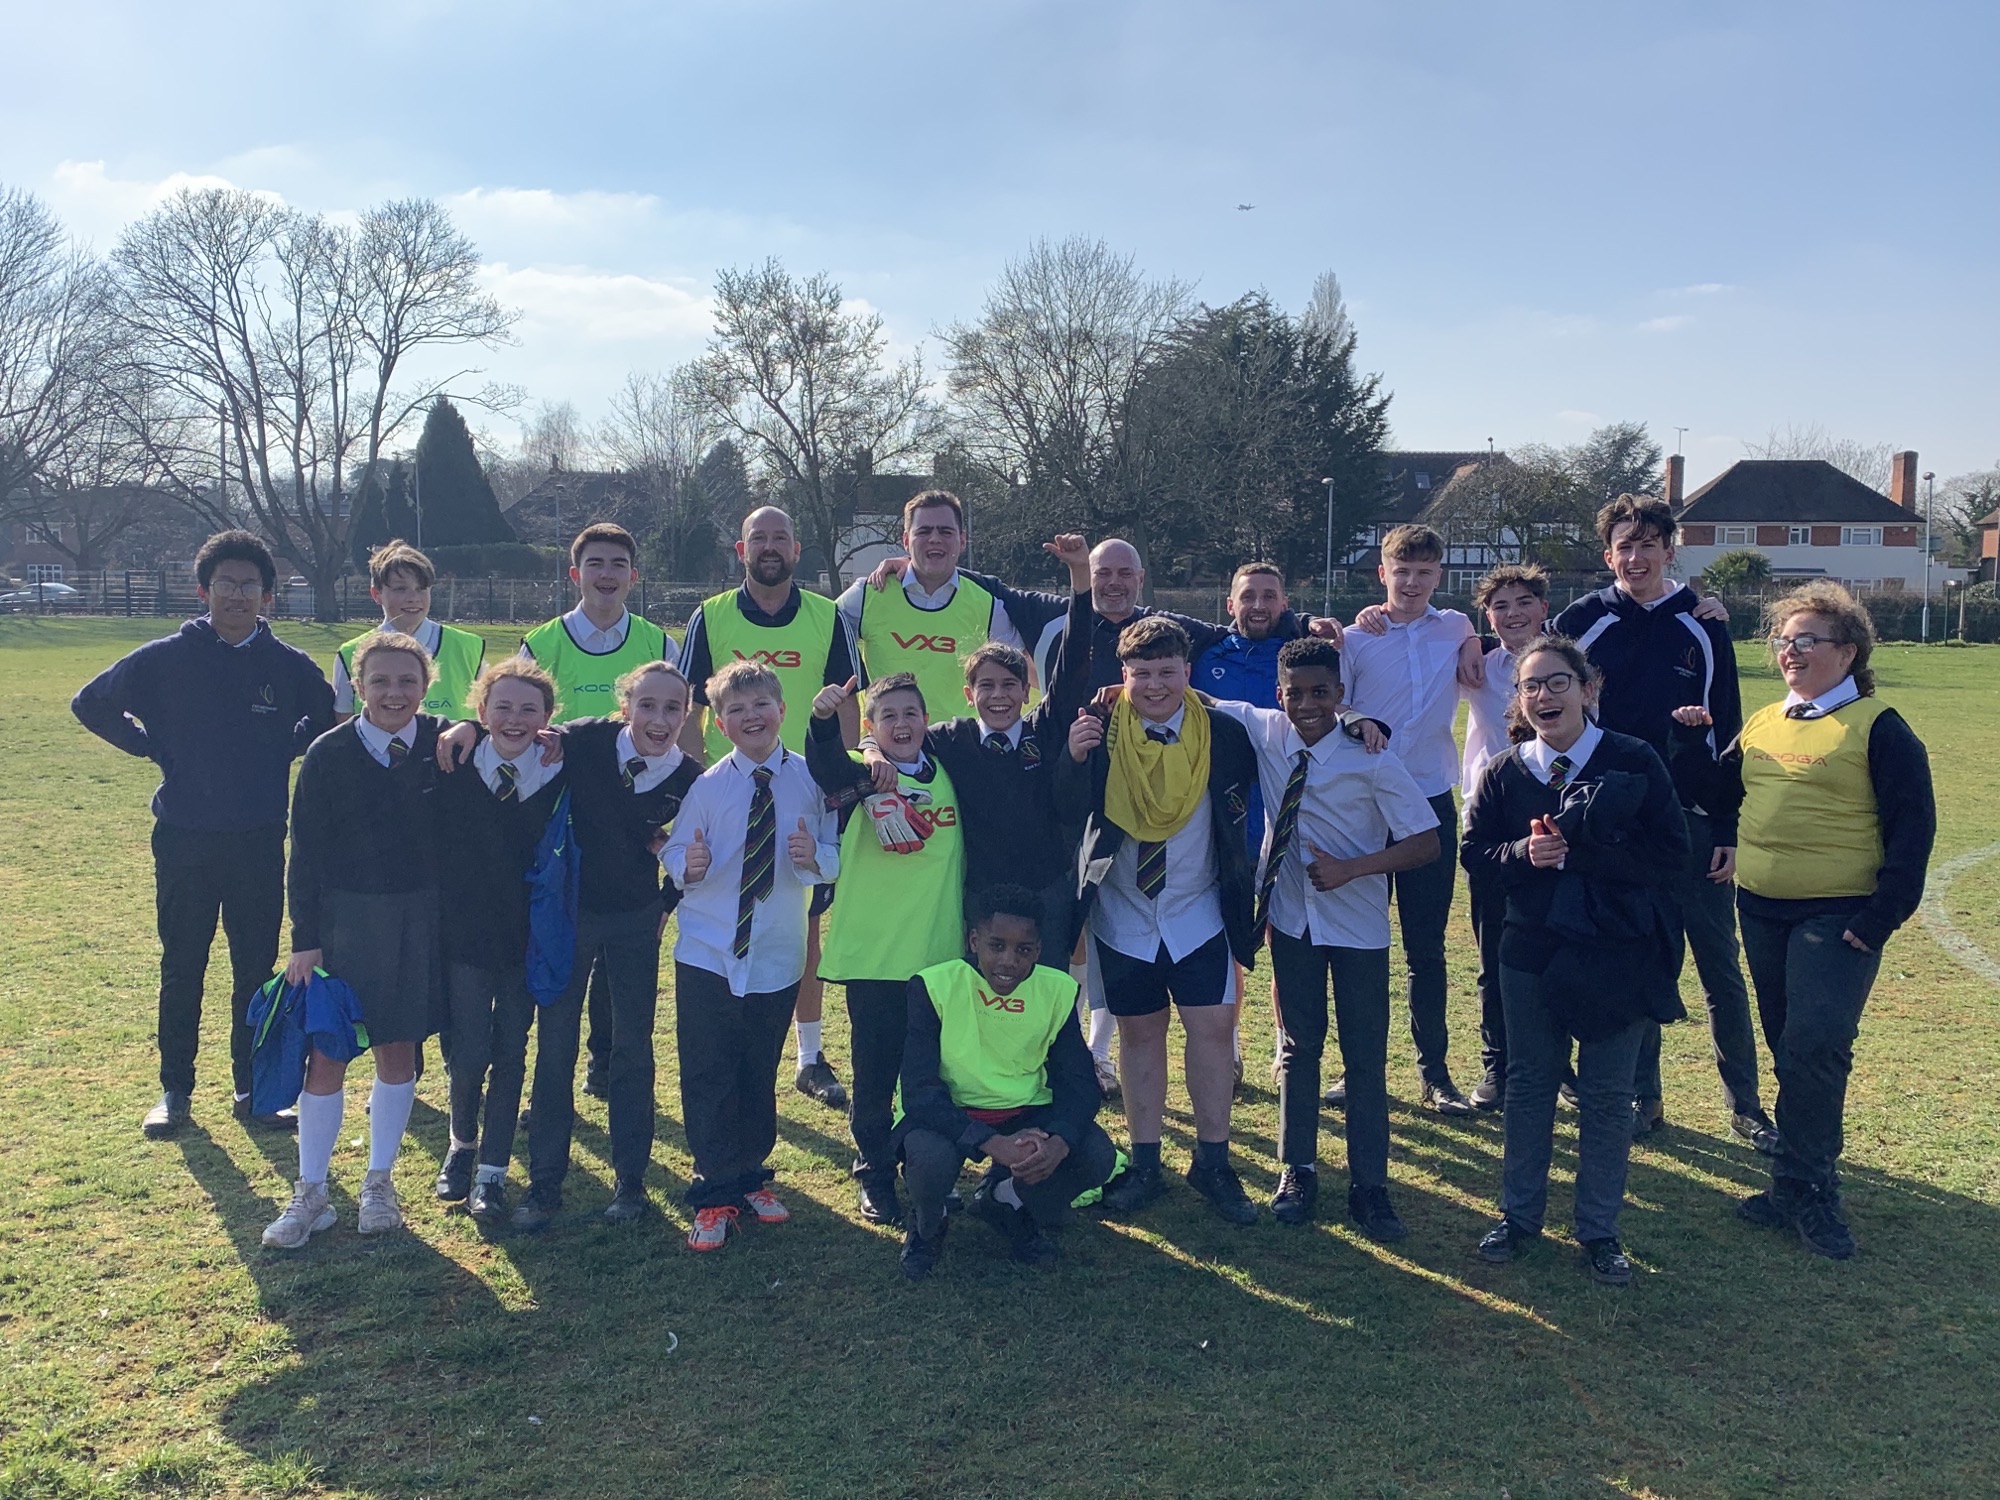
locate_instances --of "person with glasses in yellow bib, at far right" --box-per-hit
[1674,580,1938,1260]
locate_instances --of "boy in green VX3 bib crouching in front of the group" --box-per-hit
[896,886,1116,1282]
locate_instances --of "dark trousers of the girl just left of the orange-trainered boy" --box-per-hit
[528,906,660,1188]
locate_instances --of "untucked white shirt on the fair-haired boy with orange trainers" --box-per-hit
[660,748,840,996]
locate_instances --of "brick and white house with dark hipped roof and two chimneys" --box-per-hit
[1666,452,1964,594]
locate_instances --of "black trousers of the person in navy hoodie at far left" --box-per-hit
[152,822,284,1094]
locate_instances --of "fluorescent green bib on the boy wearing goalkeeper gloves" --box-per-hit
[820,756,966,980]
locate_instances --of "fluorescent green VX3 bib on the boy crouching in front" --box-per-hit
[918,958,1076,1110]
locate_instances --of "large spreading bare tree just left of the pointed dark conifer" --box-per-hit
[112,190,514,618]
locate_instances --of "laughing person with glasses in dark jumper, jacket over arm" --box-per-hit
[1460,636,1688,1286]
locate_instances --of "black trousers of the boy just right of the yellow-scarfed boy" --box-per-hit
[1270,928,1388,1188]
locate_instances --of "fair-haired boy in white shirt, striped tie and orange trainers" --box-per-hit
[660,662,840,1250]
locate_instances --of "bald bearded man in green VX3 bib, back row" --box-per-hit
[680,506,860,1110]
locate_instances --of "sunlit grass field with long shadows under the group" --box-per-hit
[0,620,2000,1500]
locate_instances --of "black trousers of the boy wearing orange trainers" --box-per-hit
[674,964,798,1208]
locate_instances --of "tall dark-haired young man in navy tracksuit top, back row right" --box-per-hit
[1554,494,1778,1152]
